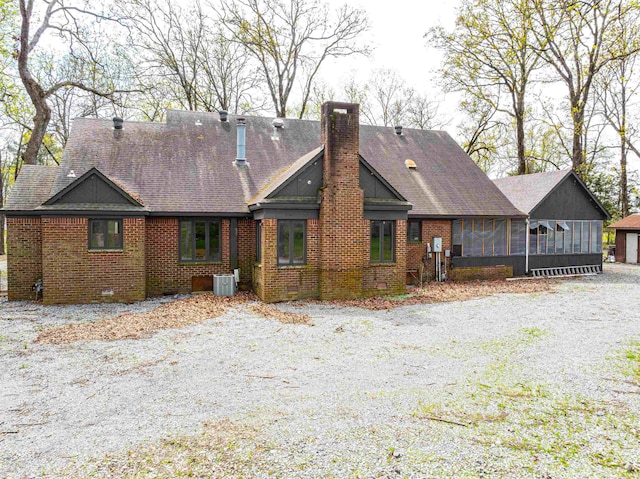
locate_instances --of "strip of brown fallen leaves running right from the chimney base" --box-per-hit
[324,279,558,310]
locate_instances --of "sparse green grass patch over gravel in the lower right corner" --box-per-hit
[413,328,640,478]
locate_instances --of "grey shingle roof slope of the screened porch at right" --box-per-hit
[493,169,571,214]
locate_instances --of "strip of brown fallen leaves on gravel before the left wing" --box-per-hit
[35,293,254,344]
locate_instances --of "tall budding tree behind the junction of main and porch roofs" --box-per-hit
[427,0,540,175]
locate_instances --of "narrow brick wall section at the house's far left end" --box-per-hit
[7,218,42,301]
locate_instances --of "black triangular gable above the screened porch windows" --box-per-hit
[531,174,609,220]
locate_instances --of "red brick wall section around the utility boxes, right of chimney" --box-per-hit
[407,220,451,283]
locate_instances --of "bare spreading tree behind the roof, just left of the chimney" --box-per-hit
[219,0,369,118]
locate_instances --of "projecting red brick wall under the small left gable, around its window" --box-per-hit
[42,218,145,304]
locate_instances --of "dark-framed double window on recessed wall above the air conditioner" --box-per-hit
[180,220,222,261]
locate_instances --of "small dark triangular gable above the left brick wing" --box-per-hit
[44,168,140,206]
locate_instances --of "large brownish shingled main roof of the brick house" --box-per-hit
[6,111,523,217]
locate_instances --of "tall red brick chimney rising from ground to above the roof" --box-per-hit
[319,102,367,299]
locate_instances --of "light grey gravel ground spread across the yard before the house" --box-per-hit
[0,265,640,478]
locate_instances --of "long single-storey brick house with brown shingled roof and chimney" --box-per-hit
[4,102,604,304]
